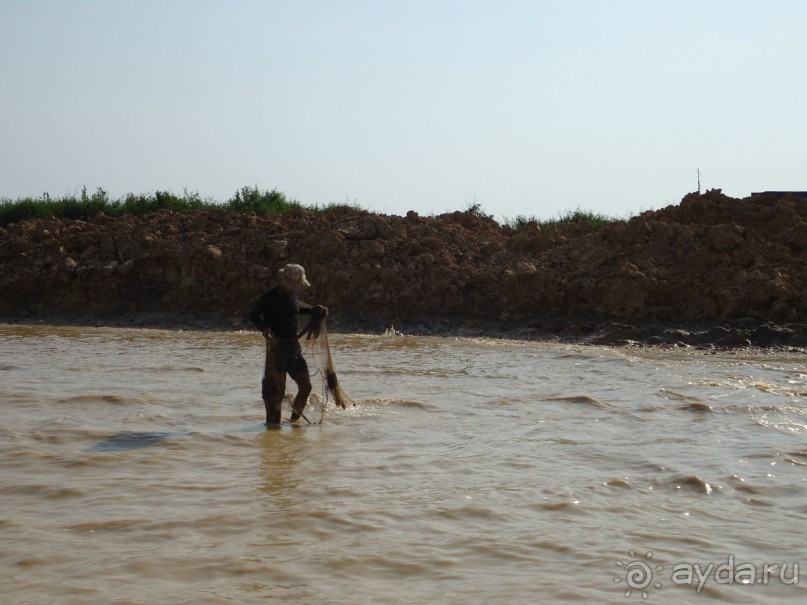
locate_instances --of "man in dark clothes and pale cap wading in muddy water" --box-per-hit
[249,264,328,424]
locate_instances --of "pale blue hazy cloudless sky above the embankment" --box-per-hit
[0,0,807,218]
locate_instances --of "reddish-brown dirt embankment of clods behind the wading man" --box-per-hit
[0,190,807,346]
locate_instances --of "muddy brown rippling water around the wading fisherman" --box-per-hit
[0,326,807,604]
